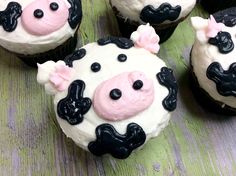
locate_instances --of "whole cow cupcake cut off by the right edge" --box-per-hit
[191,8,236,115]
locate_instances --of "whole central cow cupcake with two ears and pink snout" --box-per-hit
[37,25,177,159]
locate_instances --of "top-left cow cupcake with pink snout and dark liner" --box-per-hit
[0,0,82,66]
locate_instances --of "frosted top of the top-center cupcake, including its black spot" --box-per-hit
[110,0,196,24]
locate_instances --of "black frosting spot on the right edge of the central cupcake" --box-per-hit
[156,67,178,111]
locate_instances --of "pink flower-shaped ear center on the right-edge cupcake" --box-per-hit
[206,15,225,38]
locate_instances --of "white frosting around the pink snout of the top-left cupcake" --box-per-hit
[0,0,76,55]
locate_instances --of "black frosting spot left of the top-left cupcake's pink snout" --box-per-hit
[0,2,22,32]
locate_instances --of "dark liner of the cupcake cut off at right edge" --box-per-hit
[189,61,236,116]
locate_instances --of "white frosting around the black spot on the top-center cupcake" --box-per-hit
[110,0,196,24]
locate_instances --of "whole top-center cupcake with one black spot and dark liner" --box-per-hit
[110,0,196,43]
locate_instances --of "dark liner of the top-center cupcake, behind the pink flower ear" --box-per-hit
[116,15,178,43]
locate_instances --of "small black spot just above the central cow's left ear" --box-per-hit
[64,48,86,67]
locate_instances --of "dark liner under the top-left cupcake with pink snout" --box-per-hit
[15,32,77,67]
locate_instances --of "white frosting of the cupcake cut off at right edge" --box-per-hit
[191,17,236,108]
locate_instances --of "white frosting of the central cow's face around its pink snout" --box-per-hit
[38,43,171,150]
